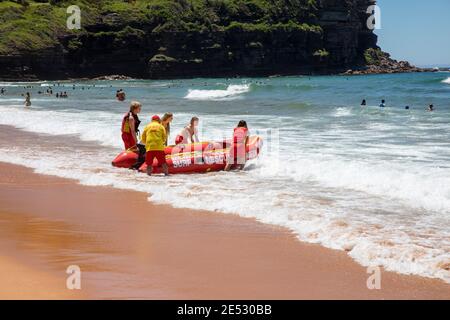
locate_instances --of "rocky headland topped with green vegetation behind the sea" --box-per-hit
[0,0,432,80]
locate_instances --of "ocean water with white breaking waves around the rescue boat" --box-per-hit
[0,73,450,283]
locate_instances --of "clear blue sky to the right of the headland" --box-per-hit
[375,0,450,66]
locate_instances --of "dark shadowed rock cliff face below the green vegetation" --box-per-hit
[0,0,377,79]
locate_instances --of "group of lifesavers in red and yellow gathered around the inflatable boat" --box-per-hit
[122,101,249,175]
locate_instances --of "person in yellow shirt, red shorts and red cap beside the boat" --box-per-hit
[141,115,169,176]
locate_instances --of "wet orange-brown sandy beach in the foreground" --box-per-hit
[0,163,450,299]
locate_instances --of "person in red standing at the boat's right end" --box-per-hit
[224,120,248,171]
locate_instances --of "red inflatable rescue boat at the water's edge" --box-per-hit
[112,136,262,174]
